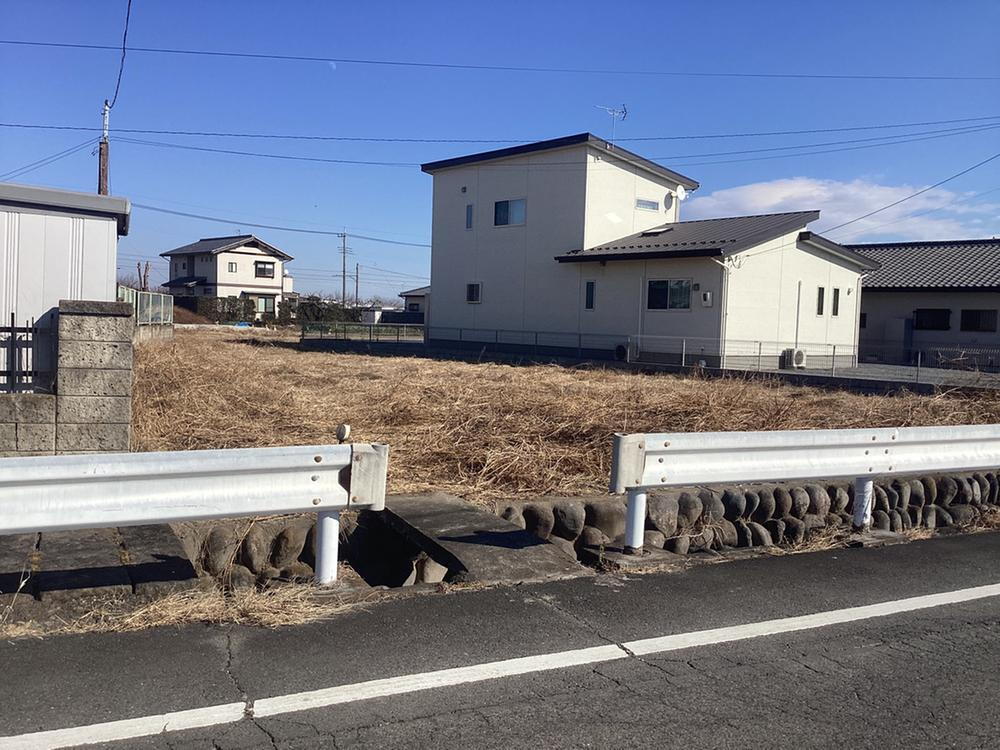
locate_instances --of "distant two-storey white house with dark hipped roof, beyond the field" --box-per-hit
[160,234,294,317]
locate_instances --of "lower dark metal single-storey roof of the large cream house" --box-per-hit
[556,211,819,263]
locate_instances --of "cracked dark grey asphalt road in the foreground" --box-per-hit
[0,534,1000,750]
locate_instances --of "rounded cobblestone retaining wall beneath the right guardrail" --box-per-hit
[501,470,1000,554]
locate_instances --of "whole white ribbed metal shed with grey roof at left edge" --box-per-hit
[0,182,131,326]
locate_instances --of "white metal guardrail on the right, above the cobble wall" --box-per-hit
[610,425,1000,551]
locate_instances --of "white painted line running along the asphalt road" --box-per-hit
[0,584,1000,750]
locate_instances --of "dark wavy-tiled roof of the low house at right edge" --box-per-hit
[846,238,1000,292]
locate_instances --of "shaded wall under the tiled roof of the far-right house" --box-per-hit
[861,289,1000,350]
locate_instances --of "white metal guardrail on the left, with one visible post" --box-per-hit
[0,443,389,584]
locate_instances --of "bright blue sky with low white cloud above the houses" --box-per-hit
[0,0,1000,298]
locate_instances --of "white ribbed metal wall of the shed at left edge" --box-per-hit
[0,207,118,325]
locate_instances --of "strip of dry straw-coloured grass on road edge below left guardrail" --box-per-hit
[0,584,356,639]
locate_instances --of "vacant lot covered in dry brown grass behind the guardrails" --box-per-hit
[134,330,1000,503]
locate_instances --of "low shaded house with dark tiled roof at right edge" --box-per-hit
[849,238,1000,366]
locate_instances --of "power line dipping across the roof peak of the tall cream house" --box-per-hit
[0,115,1000,143]
